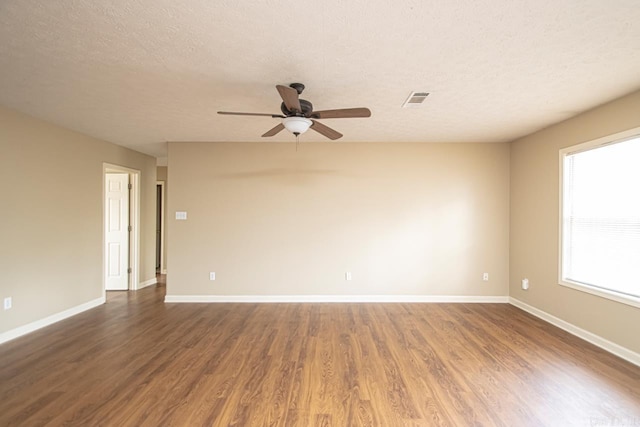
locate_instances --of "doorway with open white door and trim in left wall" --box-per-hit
[102,163,140,295]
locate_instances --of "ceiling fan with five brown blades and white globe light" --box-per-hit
[218,83,371,140]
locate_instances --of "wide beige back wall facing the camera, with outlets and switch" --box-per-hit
[167,142,509,296]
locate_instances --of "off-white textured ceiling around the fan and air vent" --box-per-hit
[0,0,640,157]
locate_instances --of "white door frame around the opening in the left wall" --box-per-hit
[102,163,140,298]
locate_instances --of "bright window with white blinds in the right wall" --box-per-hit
[560,129,640,306]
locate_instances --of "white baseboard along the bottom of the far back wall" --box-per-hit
[164,295,509,303]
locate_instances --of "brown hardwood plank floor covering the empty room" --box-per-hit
[0,286,640,427]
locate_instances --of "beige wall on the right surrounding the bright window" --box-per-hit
[509,92,640,353]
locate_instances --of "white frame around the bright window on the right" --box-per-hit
[558,127,640,307]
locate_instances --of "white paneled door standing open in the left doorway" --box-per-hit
[105,173,129,291]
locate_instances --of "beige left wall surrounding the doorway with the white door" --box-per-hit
[0,107,156,333]
